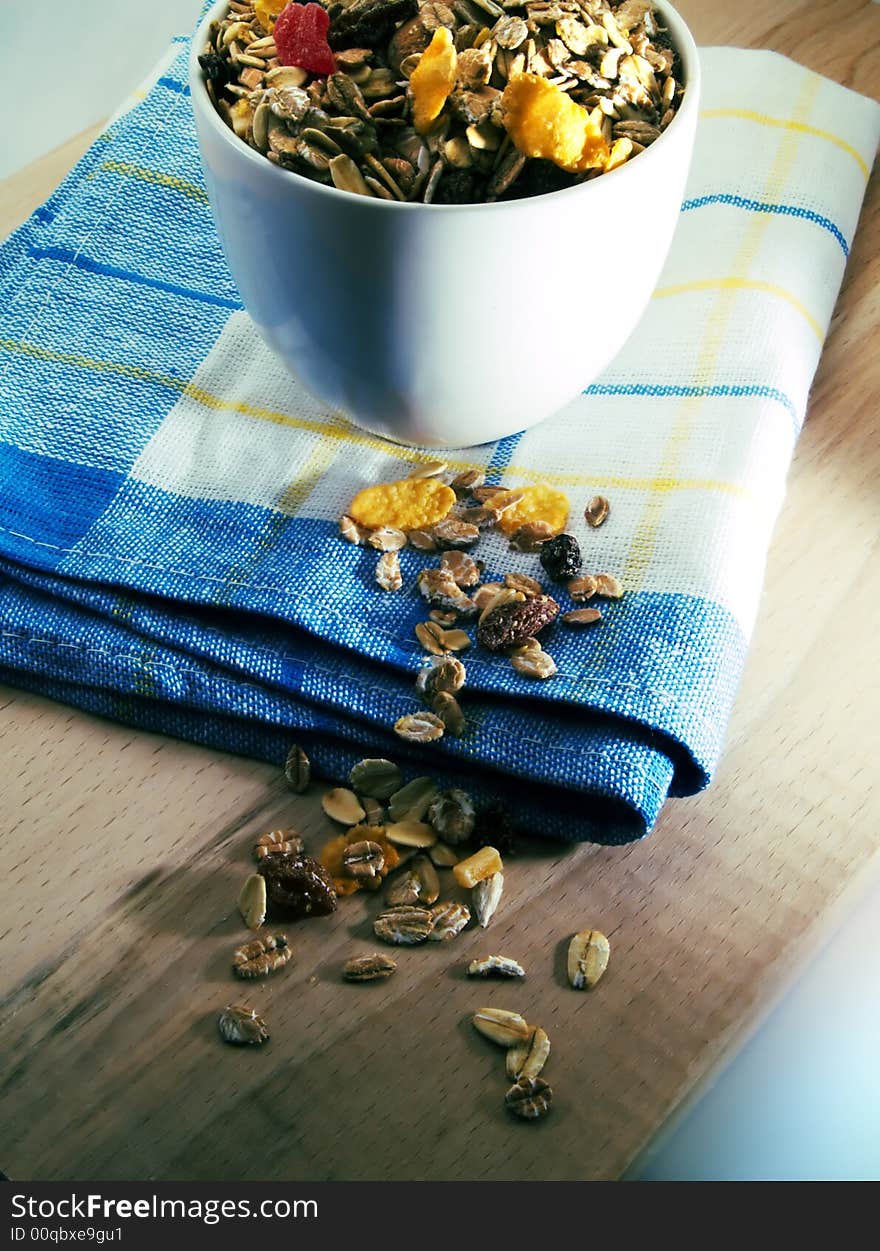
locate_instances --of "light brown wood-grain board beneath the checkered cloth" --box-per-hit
[0,0,880,1180]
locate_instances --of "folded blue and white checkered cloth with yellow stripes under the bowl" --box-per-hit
[0,31,880,843]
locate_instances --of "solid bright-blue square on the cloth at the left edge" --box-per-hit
[0,443,124,555]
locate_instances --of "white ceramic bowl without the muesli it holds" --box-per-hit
[189,0,700,447]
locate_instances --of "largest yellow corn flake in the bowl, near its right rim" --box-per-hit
[501,74,608,174]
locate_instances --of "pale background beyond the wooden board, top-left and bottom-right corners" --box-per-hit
[0,0,880,1180]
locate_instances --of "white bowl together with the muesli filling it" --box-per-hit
[190,0,700,447]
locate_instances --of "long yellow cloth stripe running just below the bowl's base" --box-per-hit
[0,339,752,499]
